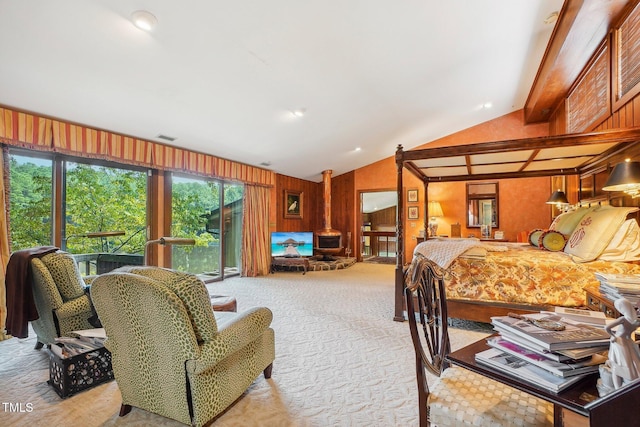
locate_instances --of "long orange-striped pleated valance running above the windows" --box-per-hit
[0,108,275,187]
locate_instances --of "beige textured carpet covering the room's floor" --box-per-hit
[0,263,487,427]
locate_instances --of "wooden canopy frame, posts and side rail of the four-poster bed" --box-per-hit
[394,128,640,321]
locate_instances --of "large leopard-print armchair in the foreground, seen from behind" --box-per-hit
[91,267,275,426]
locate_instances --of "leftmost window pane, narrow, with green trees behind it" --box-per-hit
[9,154,53,251]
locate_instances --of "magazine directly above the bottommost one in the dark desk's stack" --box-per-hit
[487,337,607,378]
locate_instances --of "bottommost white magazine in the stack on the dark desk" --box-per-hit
[476,348,589,393]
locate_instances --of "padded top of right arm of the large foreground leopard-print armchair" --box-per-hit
[186,307,273,374]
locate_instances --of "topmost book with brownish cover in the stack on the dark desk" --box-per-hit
[491,313,610,351]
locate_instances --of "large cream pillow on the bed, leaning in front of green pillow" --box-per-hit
[564,205,638,262]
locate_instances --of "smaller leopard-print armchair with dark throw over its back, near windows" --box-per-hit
[31,251,94,348]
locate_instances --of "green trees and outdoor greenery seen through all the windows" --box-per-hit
[10,156,244,273]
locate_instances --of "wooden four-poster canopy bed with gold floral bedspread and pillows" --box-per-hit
[394,128,640,322]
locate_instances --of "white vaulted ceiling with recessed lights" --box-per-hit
[0,0,562,181]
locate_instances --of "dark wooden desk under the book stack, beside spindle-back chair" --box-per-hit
[447,339,640,427]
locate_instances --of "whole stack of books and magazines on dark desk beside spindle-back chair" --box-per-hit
[476,312,610,393]
